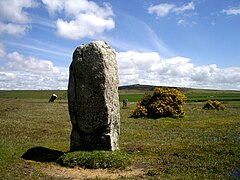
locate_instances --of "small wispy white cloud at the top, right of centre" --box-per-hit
[148,1,195,17]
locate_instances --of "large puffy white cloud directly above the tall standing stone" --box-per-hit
[42,0,115,39]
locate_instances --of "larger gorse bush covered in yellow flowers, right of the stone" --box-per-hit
[131,88,186,118]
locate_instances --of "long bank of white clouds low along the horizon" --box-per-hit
[0,48,240,90]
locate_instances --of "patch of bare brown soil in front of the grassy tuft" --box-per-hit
[42,165,145,180]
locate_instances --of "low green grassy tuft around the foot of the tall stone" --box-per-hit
[57,151,131,169]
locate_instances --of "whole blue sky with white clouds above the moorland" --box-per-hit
[0,0,240,90]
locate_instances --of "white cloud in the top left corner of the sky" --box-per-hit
[0,0,37,35]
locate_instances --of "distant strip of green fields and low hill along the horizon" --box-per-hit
[0,85,240,102]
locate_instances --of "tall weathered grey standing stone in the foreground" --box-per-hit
[68,41,120,151]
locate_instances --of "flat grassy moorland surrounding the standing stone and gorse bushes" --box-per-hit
[0,87,240,179]
